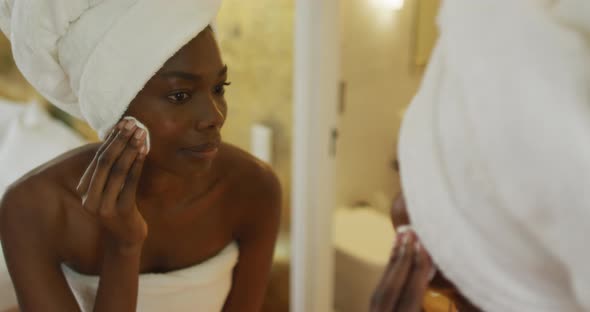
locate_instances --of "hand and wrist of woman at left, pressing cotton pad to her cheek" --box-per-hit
[77,120,147,251]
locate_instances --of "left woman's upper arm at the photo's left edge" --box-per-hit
[0,185,80,312]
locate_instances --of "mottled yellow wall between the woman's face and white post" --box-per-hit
[217,0,294,229]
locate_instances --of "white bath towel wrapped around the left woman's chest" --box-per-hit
[63,243,239,312]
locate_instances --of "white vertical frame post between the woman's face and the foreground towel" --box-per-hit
[290,0,340,312]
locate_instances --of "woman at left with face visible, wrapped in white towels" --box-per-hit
[0,0,281,311]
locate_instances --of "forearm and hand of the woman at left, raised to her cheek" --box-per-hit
[77,120,147,311]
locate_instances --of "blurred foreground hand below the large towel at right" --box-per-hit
[371,228,433,312]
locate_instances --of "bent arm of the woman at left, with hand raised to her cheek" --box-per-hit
[0,120,147,312]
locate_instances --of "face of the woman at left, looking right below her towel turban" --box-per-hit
[126,28,227,174]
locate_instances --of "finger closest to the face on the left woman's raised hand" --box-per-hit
[100,128,146,217]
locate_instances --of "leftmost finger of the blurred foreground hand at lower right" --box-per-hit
[371,232,415,312]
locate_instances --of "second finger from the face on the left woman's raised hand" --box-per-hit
[84,121,135,214]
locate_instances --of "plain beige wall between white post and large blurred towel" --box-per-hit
[336,0,434,211]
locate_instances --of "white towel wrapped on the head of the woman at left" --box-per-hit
[0,0,221,137]
